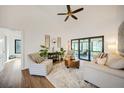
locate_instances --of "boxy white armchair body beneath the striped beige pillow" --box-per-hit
[29,59,53,76]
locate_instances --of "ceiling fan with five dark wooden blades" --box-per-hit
[58,5,84,22]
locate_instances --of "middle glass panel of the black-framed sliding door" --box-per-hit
[79,39,89,60]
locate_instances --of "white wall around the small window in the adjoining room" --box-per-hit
[0,28,21,60]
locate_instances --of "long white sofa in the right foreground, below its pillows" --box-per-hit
[83,62,124,88]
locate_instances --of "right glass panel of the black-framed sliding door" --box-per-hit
[90,38,103,60]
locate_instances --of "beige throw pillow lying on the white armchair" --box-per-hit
[29,53,44,63]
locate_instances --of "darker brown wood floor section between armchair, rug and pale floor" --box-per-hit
[22,69,54,88]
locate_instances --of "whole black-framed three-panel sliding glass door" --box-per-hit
[71,36,104,61]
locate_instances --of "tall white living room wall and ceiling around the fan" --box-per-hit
[0,6,124,67]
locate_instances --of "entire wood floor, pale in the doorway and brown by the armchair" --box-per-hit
[0,60,54,88]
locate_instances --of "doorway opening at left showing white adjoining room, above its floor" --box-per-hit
[0,28,23,71]
